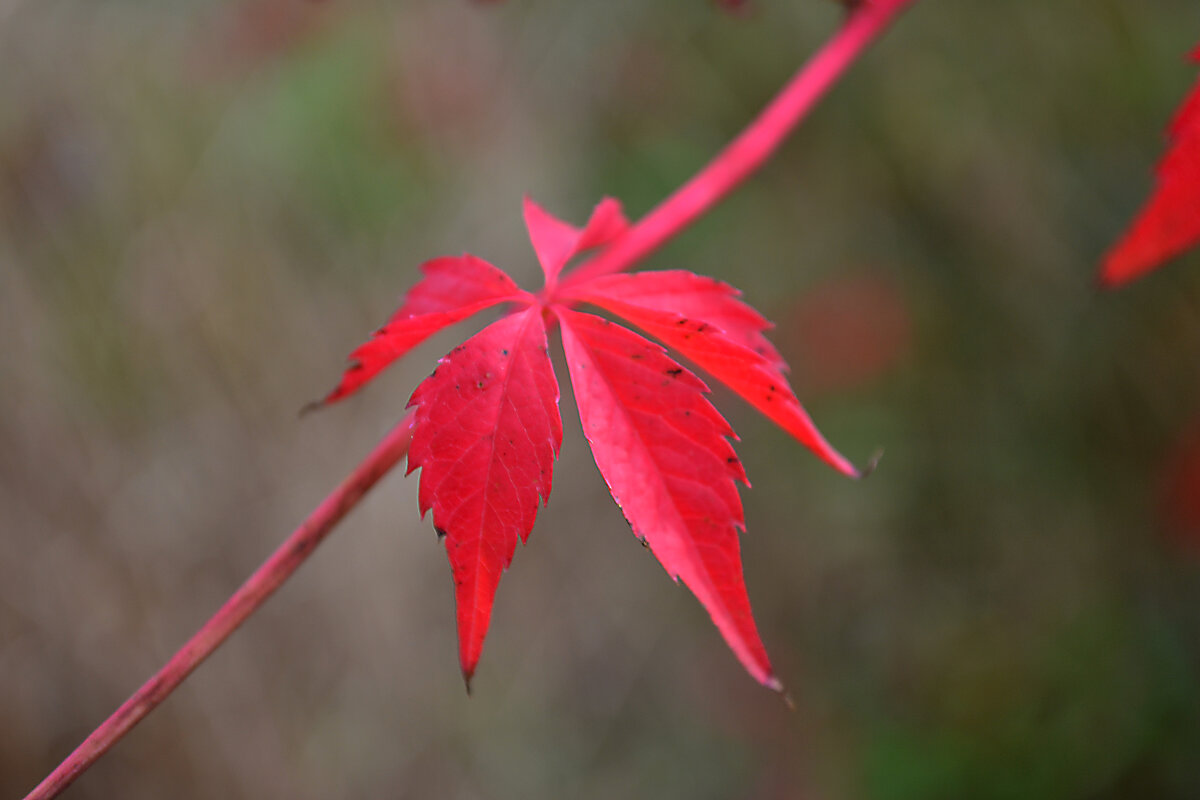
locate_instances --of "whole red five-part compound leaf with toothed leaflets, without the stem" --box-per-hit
[324,199,858,690]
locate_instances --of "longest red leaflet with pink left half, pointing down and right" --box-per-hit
[554,306,780,690]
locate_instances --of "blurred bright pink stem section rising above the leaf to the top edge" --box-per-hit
[563,0,916,284]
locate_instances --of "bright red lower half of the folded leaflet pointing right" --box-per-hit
[571,272,859,477]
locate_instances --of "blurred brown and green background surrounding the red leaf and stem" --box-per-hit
[7,0,1200,800]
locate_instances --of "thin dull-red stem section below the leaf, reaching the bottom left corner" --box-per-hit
[25,414,413,800]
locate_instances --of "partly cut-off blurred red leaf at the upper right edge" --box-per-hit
[1100,49,1200,287]
